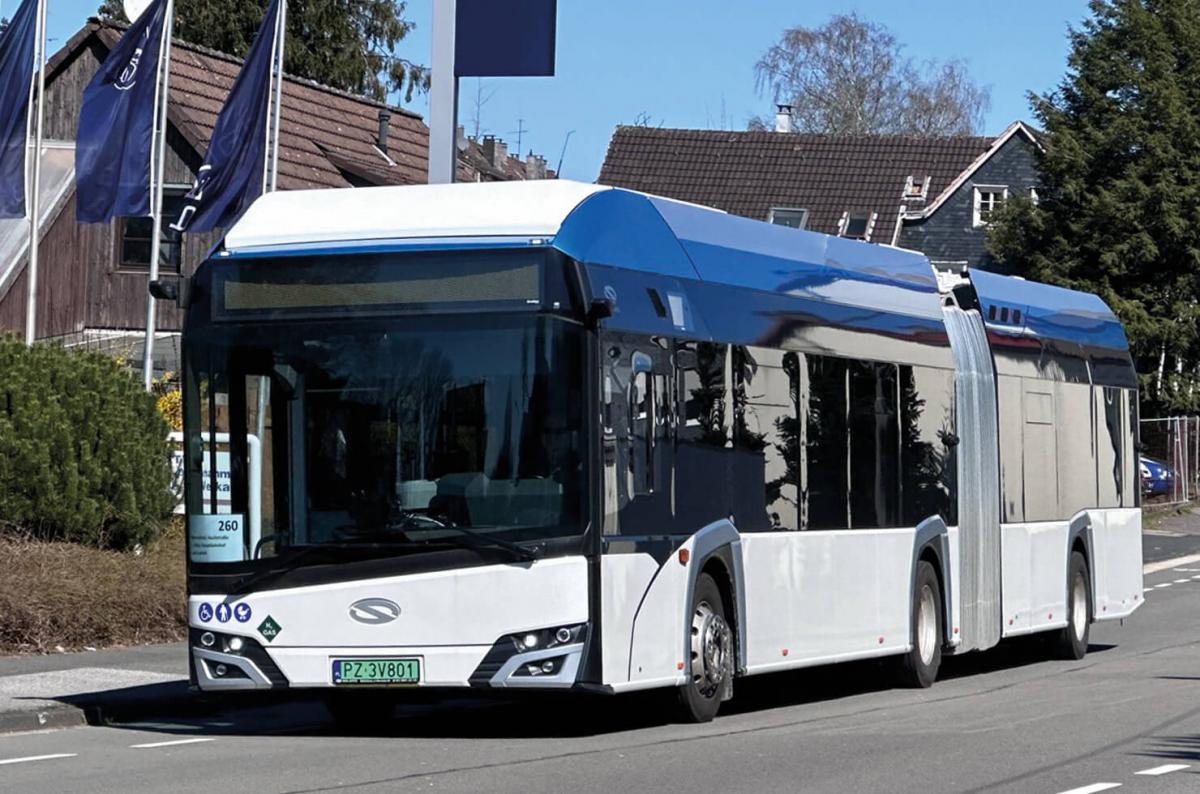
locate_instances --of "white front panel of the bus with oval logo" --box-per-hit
[188,557,588,686]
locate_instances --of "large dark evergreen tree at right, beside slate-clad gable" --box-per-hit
[989,0,1200,411]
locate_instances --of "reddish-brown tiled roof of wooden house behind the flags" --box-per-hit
[56,19,544,190]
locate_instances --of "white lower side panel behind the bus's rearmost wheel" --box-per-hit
[1090,507,1142,620]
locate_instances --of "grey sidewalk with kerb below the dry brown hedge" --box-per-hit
[0,643,194,733]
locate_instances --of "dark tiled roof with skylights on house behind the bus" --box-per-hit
[599,126,995,242]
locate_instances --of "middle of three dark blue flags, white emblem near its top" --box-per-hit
[76,0,167,223]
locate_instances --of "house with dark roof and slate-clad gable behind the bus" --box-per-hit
[599,112,1039,270]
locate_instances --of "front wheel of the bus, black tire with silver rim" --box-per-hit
[679,573,733,722]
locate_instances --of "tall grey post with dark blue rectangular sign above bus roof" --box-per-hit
[430,0,558,185]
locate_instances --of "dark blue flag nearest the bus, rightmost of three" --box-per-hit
[170,0,282,231]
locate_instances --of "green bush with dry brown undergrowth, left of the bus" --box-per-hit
[0,336,186,652]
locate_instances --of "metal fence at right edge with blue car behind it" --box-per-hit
[1138,416,1200,505]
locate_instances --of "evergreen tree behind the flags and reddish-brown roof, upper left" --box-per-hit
[100,0,428,102]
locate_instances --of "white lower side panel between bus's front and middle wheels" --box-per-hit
[742,529,914,673]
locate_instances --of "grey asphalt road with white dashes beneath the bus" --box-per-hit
[0,547,1200,794]
